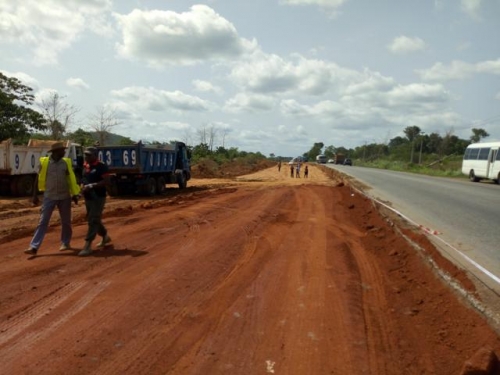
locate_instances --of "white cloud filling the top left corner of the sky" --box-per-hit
[0,0,111,65]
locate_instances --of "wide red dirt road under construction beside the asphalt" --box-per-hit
[0,166,500,375]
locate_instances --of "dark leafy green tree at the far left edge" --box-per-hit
[0,73,47,141]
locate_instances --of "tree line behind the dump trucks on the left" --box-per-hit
[0,72,265,162]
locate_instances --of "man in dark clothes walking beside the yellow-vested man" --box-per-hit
[78,147,111,256]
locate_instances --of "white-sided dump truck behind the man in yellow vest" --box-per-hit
[0,138,83,197]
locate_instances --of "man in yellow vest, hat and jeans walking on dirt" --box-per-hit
[24,142,80,255]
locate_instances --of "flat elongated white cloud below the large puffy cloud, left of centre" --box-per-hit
[111,86,214,113]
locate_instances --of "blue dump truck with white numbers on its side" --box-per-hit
[97,142,191,196]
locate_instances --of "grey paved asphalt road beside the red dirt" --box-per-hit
[327,164,500,293]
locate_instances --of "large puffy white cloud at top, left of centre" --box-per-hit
[115,5,256,67]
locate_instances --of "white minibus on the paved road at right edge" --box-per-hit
[462,142,500,184]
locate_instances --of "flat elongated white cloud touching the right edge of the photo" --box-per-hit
[416,59,500,81]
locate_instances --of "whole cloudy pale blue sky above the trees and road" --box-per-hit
[0,0,500,156]
